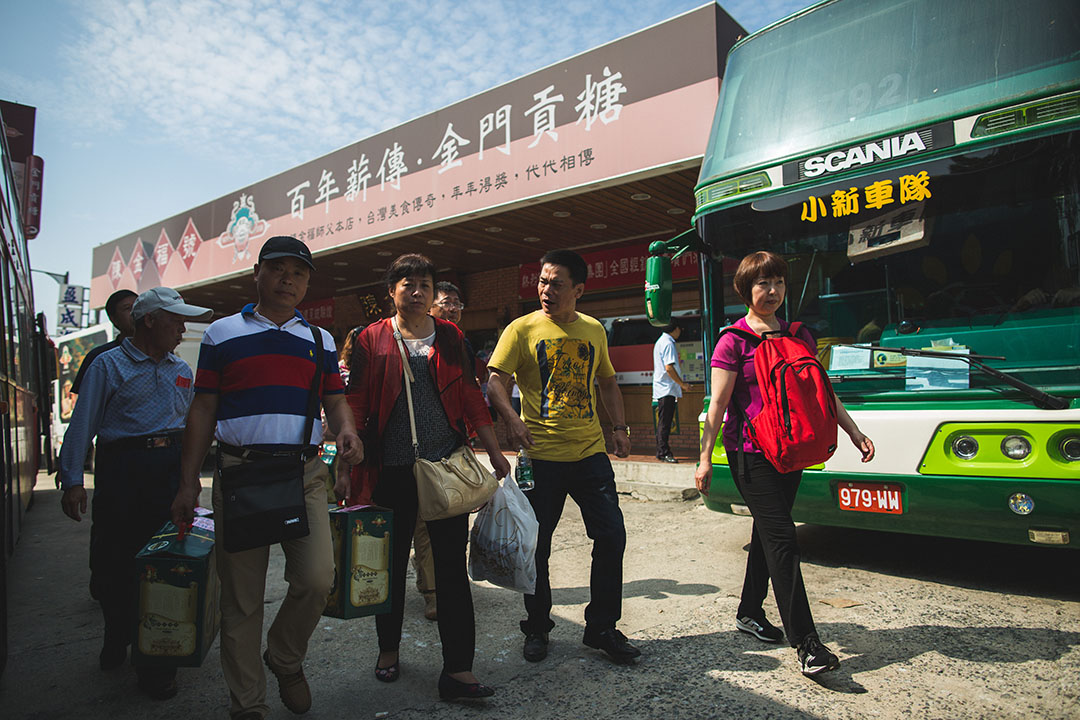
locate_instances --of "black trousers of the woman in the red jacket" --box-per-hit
[372,465,476,673]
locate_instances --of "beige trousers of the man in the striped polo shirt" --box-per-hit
[213,456,334,716]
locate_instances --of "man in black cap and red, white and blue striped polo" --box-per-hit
[173,235,363,720]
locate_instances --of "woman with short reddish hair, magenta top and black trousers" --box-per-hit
[694,252,874,675]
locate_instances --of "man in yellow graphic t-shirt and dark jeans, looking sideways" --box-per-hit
[487,250,642,663]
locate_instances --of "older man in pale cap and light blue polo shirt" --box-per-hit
[59,287,214,699]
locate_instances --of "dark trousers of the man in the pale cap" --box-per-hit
[90,440,180,646]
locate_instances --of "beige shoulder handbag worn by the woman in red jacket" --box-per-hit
[391,317,499,521]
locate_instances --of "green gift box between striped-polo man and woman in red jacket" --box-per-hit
[323,505,394,619]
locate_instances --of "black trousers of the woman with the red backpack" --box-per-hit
[728,452,816,648]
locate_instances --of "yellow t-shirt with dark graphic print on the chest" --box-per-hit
[487,310,615,462]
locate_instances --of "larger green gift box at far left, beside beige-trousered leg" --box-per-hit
[132,517,220,667]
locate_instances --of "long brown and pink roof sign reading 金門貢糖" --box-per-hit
[91,4,744,307]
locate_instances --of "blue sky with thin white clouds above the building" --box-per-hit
[0,0,811,321]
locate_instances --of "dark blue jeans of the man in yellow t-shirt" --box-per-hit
[522,452,626,635]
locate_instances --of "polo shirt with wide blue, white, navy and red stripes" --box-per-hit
[195,303,345,447]
